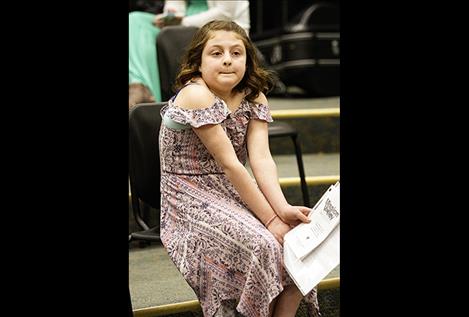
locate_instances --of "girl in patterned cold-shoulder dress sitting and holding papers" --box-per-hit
[159,21,319,317]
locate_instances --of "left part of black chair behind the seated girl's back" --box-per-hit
[129,102,166,242]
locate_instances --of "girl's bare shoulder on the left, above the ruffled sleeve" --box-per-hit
[174,82,215,109]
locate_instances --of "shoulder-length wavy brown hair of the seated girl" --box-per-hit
[174,20,277,102]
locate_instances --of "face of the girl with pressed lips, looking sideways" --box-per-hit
[199,30,246,91]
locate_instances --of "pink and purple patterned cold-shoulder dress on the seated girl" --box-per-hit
[159,92,320,317]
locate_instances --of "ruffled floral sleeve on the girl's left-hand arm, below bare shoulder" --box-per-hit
[162,101,231,128]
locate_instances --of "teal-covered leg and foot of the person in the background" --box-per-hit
[129,11,161,108]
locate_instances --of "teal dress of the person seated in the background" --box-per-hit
[129,0,208,101]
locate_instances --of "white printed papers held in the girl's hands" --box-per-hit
[283,182,340,295]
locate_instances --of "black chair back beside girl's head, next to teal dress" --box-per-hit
[156,25,197,101]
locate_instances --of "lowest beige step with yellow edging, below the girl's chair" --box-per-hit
[129,244,340,317]
